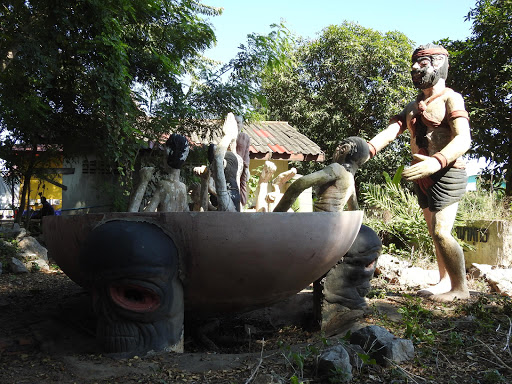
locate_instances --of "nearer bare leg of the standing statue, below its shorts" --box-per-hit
[430,203,469,302]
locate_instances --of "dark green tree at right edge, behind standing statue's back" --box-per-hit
[442,0,512,196]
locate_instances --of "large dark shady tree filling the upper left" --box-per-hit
[0,0,220,220]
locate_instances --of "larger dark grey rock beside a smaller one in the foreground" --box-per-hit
[350,325,414,366]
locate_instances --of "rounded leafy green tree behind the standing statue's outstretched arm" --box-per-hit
[263,22,415,185]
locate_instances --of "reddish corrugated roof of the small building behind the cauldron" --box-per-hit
[243,121,325,161]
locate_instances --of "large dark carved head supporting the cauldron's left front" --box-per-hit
[80,220,183,357]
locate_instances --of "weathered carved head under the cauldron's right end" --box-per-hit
[324,225,382,309]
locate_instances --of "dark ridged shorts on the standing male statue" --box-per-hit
[414,168,468,212]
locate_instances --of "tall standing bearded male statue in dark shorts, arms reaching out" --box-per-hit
[368,44,471,302]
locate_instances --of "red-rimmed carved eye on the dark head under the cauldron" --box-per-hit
[110,284,160,312]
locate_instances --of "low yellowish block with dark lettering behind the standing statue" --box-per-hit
[455,220,512,268]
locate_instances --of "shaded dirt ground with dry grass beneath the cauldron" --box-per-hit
[0,271,512,384]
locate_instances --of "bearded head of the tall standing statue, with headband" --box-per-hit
[411,44,448,89]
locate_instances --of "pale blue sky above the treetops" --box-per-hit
[202,0,476,62]
